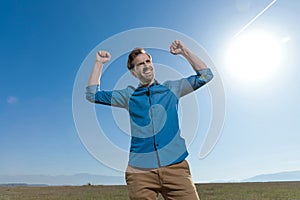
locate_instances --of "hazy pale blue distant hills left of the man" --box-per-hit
[0,173,125,185]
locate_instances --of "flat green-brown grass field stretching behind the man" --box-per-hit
[0,182,300,200]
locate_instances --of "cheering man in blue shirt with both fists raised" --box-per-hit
[86,40,213,200]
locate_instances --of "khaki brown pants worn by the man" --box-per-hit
[126,160,199,200]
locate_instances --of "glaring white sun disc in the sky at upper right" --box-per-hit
[226,31,282,84]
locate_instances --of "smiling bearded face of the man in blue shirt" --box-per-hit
[131,53,154,86]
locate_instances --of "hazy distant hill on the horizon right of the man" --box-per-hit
[241,171,300,182]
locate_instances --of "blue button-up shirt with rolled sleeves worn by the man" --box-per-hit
[86,69,213,168]
